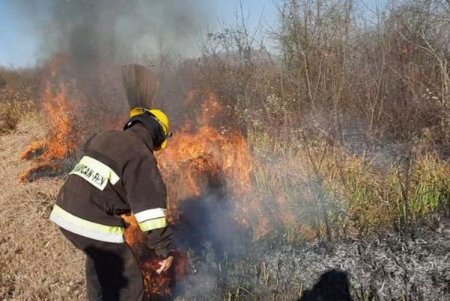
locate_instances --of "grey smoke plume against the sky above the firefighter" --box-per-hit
[14,0,206,65]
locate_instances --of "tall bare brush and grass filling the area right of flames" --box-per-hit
[187,0,450,242]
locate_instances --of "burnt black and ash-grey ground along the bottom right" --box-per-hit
[173,220,450,301]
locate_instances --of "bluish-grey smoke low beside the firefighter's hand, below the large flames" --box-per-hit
[173,191,251,300]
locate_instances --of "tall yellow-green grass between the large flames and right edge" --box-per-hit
[249,130,450,243]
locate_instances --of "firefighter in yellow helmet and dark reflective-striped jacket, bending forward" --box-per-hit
[50,108,173,300]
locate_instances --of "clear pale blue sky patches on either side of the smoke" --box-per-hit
[0,0,386,68]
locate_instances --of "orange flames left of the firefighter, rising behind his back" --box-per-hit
[20,53,125,182]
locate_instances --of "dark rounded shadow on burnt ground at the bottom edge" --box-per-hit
[299,270,352,301]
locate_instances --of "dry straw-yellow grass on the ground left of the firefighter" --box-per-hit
[0,115,86,300]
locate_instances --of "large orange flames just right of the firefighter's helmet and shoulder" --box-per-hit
[158,93,269,236]
